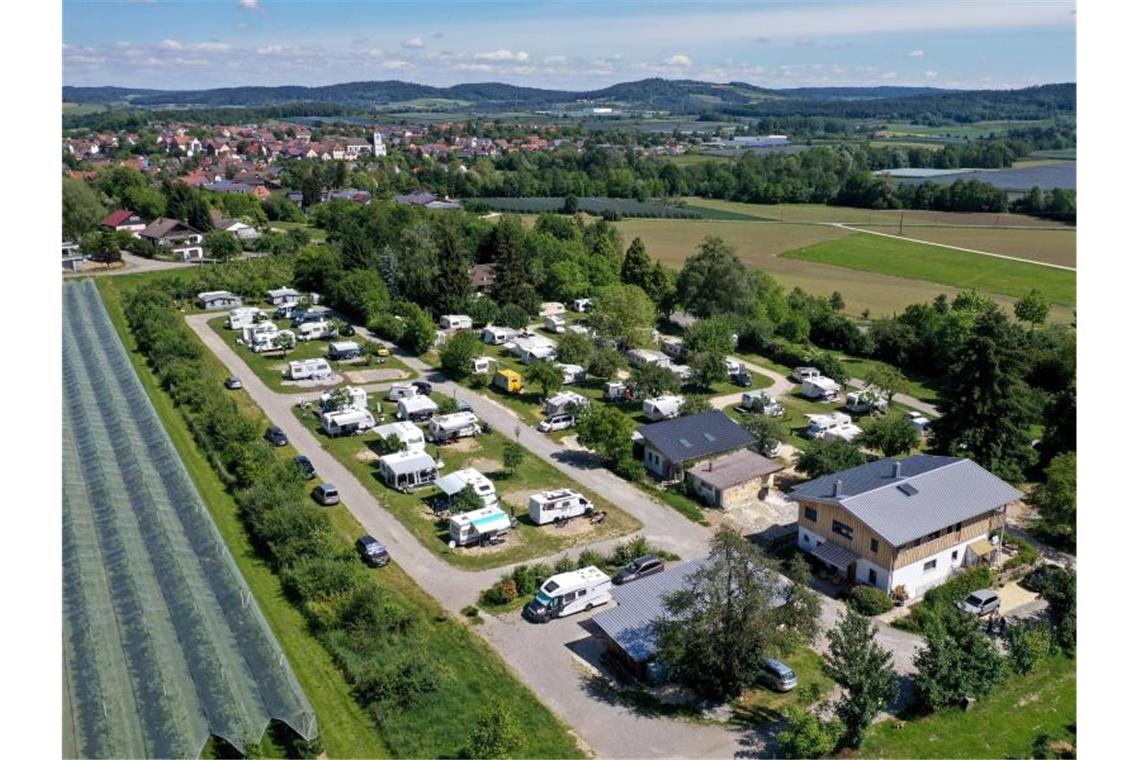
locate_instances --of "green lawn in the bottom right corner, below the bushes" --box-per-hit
[858,655,1076,758]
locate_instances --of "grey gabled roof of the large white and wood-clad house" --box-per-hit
[789,455,1024,546]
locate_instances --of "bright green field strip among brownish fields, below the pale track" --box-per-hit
[783,235,1076,305]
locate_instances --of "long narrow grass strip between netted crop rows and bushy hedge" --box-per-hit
[97,278,391,758]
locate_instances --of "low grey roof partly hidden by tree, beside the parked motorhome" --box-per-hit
[593,557,784,662]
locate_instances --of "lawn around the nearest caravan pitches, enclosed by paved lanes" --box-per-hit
[294,407,641,570]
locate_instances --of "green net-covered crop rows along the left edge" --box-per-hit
[64,283,317,757]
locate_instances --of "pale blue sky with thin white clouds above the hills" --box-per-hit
[63,0,1076,90]
